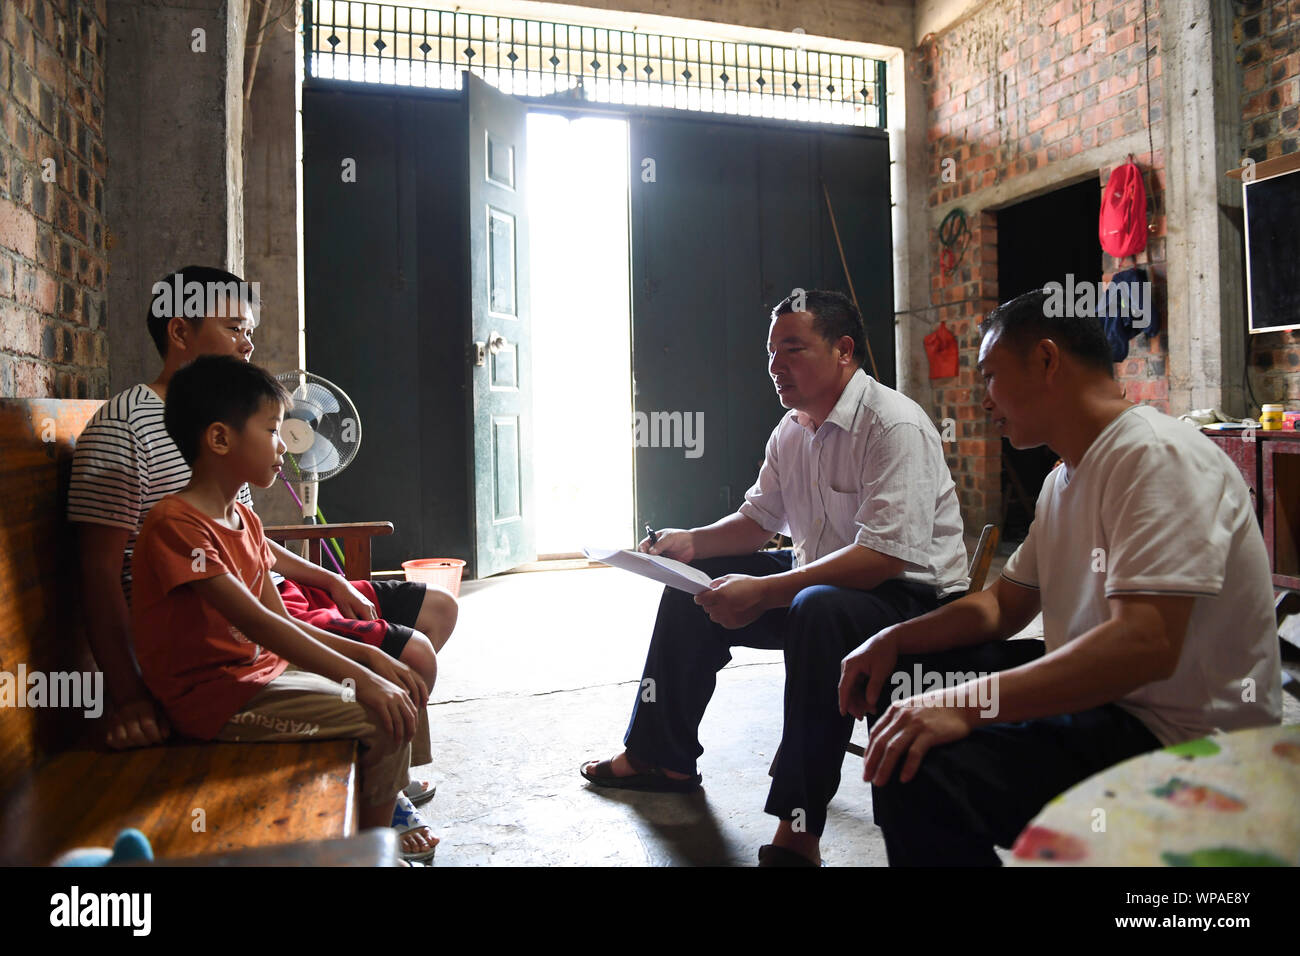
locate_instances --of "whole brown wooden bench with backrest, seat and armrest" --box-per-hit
[0,399,391,865]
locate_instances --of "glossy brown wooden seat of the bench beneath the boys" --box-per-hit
[0,740,356,865]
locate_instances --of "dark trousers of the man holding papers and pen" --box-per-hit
[623,551,940,835]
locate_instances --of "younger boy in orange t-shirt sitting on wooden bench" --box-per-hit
[131,356,438,860]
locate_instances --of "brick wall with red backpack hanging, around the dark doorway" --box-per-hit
[917,0,1169,528]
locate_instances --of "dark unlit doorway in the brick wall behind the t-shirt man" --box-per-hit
[997,179,1101,541]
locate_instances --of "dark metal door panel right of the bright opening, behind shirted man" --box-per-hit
[629,114,894,527]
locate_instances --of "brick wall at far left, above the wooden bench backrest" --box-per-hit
[0,0,108,398]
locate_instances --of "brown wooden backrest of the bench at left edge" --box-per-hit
[0,399,101,791]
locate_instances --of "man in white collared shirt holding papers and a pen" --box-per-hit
[581,290,969,865]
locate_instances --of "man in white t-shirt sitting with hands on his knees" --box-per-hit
[840,291,1282,865]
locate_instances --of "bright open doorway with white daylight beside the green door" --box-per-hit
[528,111,637,557]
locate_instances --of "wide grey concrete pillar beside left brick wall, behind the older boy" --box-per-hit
[104,0,244,392]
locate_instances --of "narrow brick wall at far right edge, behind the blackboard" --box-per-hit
[1234,0,1300,408]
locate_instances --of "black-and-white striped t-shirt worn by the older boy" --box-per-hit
[68,385,252,600]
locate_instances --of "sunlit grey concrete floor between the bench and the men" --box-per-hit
[417,557,1300,866]
